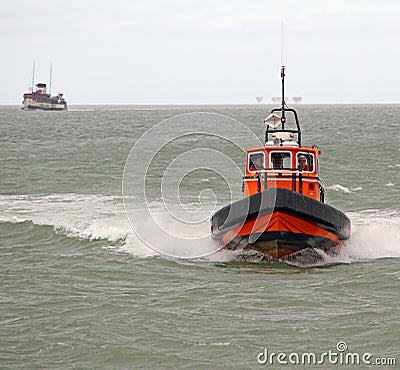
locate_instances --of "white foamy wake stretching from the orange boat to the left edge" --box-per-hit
[0,194,218,257]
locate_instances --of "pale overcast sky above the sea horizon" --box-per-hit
[0,0,400,105]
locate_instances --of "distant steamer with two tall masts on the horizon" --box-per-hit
[21,63,67,110]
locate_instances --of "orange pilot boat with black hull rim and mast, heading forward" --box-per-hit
[211,67,350,262]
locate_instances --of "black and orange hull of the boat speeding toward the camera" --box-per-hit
[211,189,350,261]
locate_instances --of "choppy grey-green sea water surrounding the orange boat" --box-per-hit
[0,105,400,369]
